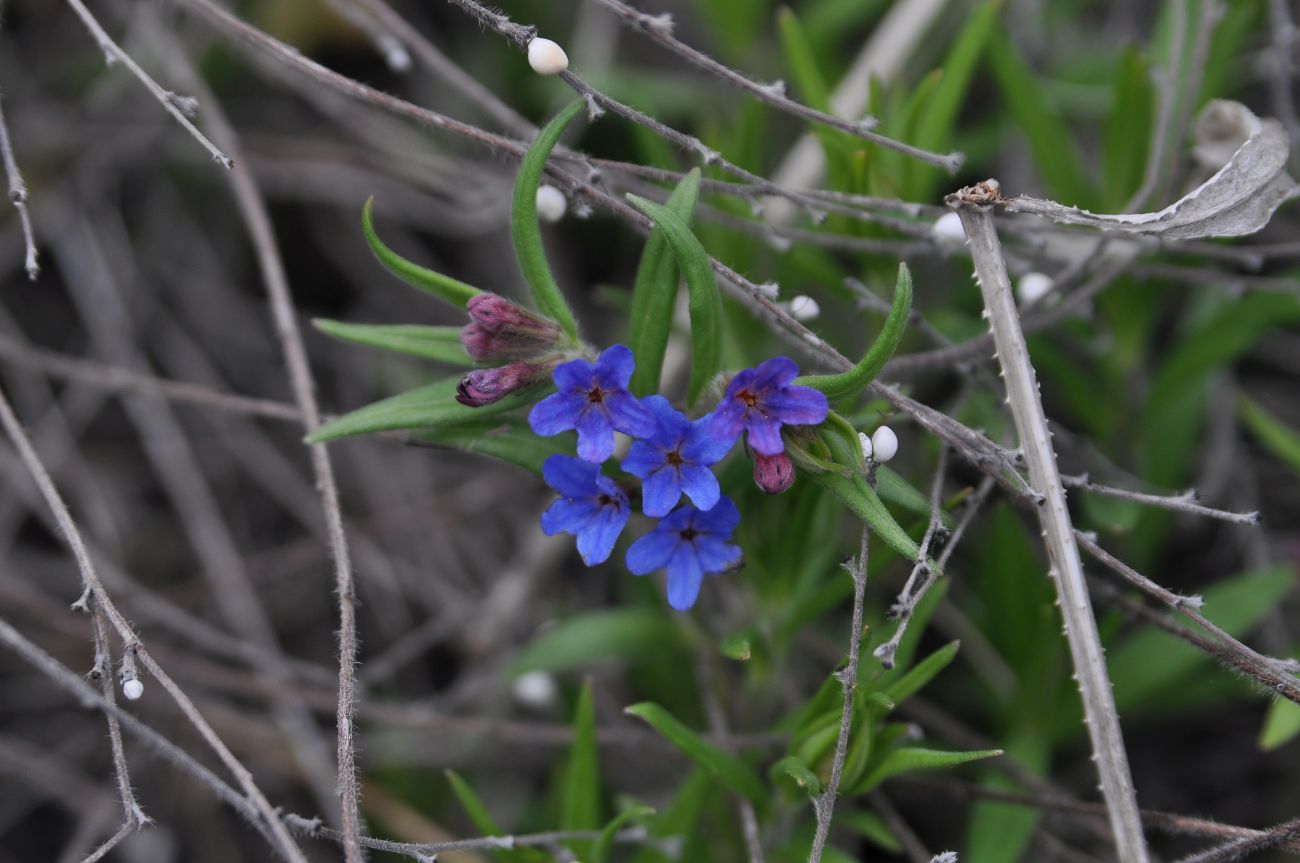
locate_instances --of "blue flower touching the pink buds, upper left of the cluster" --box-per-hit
[528,344,655,463]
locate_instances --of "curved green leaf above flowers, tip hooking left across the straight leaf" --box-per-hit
[628,195,723,404]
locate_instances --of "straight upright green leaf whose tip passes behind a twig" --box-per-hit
[628,168,699,396]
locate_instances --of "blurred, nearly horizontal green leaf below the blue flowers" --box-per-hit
[508,608,681,677]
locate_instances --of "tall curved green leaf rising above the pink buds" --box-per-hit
[510,101,582,337]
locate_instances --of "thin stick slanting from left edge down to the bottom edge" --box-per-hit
[0,390,307,863]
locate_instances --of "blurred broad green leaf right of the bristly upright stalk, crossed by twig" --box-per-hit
[1106,567,1296,715]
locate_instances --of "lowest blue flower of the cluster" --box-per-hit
[628,498,740,611]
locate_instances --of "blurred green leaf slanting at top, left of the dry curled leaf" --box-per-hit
[987,29,1095,207]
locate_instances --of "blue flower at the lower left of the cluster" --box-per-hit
[542,455,632,567]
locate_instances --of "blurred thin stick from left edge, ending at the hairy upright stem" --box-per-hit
[0,335,303,422]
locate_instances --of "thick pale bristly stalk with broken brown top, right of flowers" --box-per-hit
[948,181,1148,863]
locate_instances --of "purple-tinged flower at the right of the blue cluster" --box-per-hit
[710,356,828,455]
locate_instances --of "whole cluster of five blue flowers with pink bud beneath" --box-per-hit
[528,344,827,611]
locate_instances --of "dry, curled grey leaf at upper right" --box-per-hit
[1006,100,1297,239]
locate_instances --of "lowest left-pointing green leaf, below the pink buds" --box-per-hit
[307,378,537,443]
